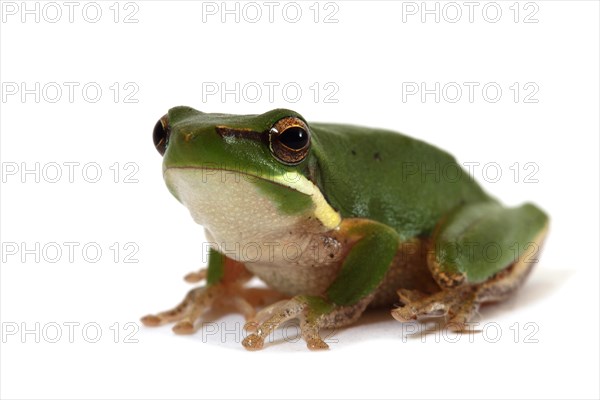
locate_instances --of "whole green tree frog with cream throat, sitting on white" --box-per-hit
[141,106,549,350]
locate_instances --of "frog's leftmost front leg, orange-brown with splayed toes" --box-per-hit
[141,249,271,334]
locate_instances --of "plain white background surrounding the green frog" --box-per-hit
[0,1,599,399]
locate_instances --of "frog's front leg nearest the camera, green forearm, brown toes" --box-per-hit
[243,218,399,350]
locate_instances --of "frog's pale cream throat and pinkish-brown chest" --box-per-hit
[165,168,340,295]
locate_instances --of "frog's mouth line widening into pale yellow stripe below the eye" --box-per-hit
[163,167,342,229]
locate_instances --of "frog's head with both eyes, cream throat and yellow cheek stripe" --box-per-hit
[153,107,340,239]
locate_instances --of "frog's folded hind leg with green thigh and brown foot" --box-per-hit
[392,202,548,331]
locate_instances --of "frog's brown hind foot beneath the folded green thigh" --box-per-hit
[392,286,481,331]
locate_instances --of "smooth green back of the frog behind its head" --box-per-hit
[310,123,489,240]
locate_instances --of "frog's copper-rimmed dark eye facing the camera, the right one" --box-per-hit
[269,117,310,165]
